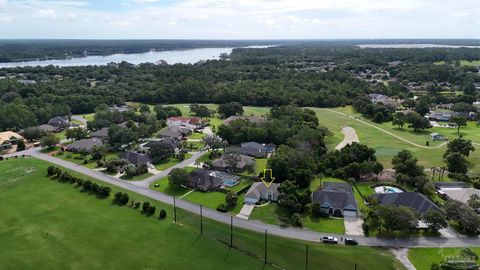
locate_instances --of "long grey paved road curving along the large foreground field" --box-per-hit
[20,152,480,248]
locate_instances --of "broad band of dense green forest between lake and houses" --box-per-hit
[0,42,480,129]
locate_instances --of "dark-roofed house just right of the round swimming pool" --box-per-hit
[372,192,443,214]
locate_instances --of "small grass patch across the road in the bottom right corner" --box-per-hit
[408,248,480,270]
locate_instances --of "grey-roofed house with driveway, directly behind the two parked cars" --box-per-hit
[312,182,358,217]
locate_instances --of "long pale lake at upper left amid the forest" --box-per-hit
[0,46,235,68]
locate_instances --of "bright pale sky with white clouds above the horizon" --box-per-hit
[0,0,480,39]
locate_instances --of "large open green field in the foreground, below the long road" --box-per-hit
[0,159,405,270]
